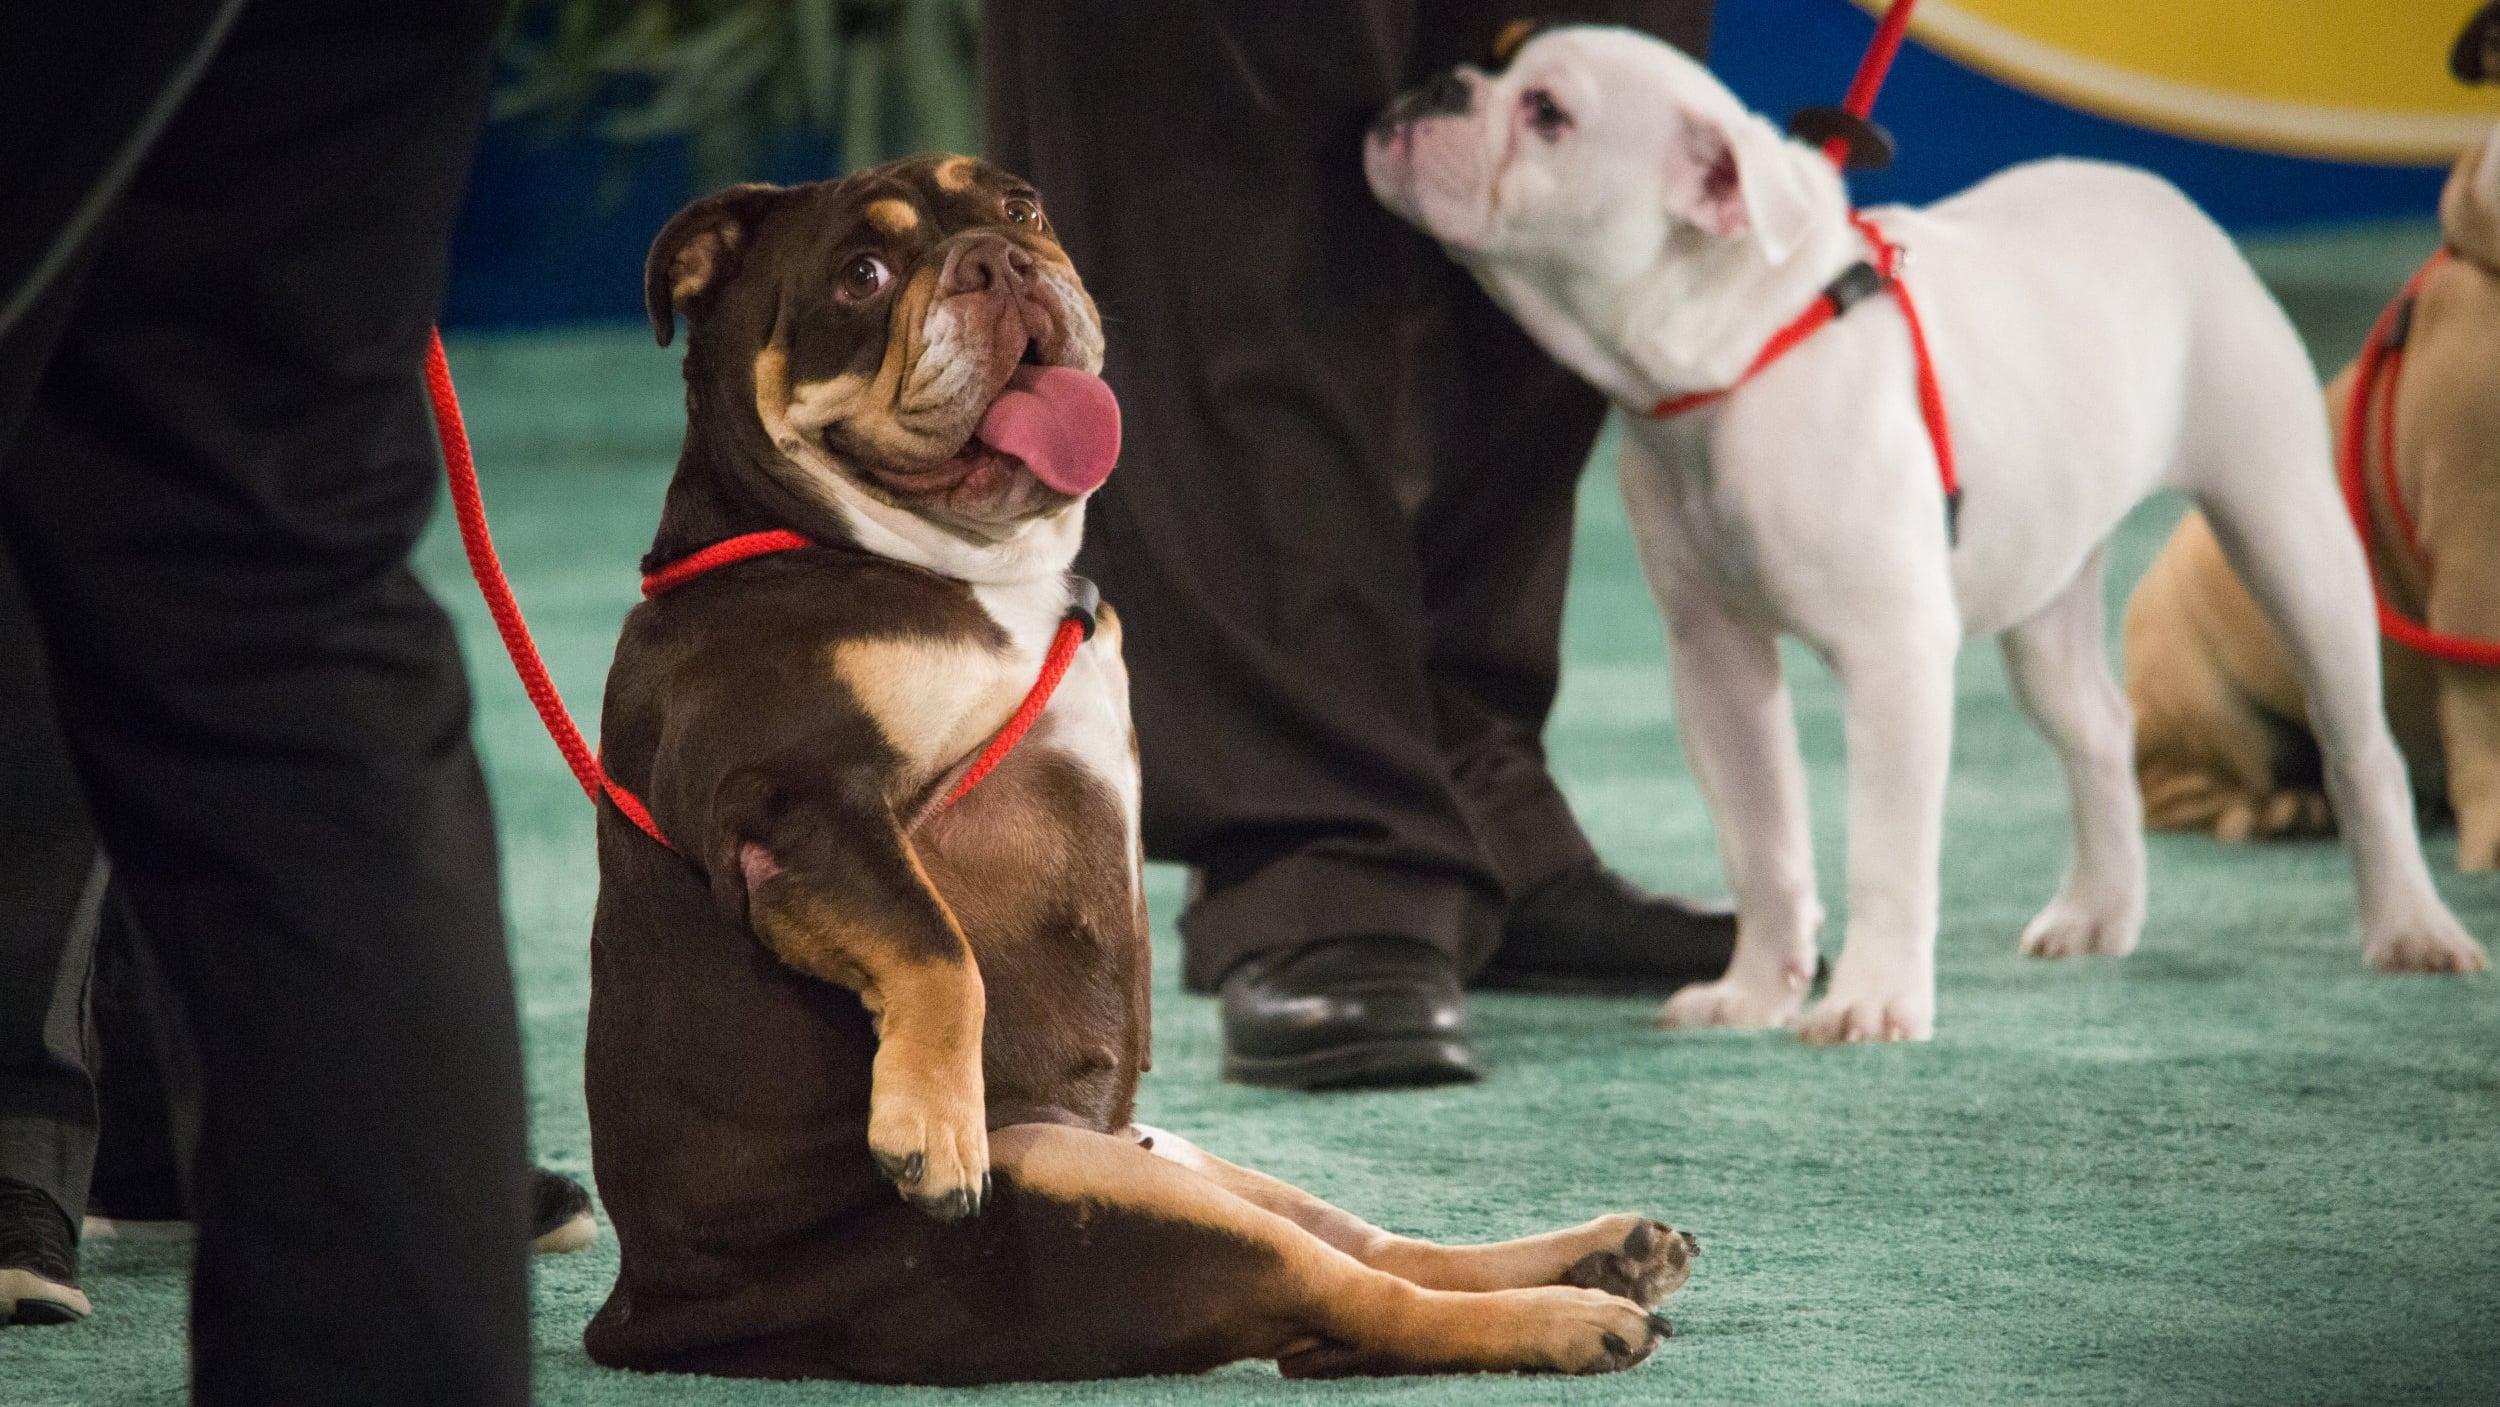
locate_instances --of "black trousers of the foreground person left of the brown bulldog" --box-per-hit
[0,0,530,1405]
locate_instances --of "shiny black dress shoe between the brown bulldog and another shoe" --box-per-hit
[1218,937,1483,1090]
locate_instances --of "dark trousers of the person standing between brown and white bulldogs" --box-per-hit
[985,0,1710,987]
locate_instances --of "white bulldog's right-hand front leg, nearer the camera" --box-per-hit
[1798,629,1960,1045]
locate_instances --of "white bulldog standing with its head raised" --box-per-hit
[1365,27,2488,1042]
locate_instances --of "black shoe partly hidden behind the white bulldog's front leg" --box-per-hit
[1475,862,1735,995]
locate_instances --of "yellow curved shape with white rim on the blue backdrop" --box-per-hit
[1855,0,2500,165]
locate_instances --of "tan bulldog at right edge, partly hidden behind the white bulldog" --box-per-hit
[2125,132,2500,870]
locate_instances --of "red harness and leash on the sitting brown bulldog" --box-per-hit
[425,332,1098,850]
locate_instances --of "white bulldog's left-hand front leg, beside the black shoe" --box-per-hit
[1658,582,1823,1027]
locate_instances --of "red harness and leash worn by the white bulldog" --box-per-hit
[1648,0,1963,537]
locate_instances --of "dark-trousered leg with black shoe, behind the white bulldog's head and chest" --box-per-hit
[1400,0,1735,992]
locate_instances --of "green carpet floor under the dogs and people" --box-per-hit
[0,227,2500,1407]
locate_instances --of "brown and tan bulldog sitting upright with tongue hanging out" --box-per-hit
[585,157,1695,1382]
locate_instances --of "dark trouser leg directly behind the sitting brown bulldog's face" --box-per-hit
[985,0,1500,1077]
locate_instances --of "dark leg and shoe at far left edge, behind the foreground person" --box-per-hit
[0,534,105,1325]
